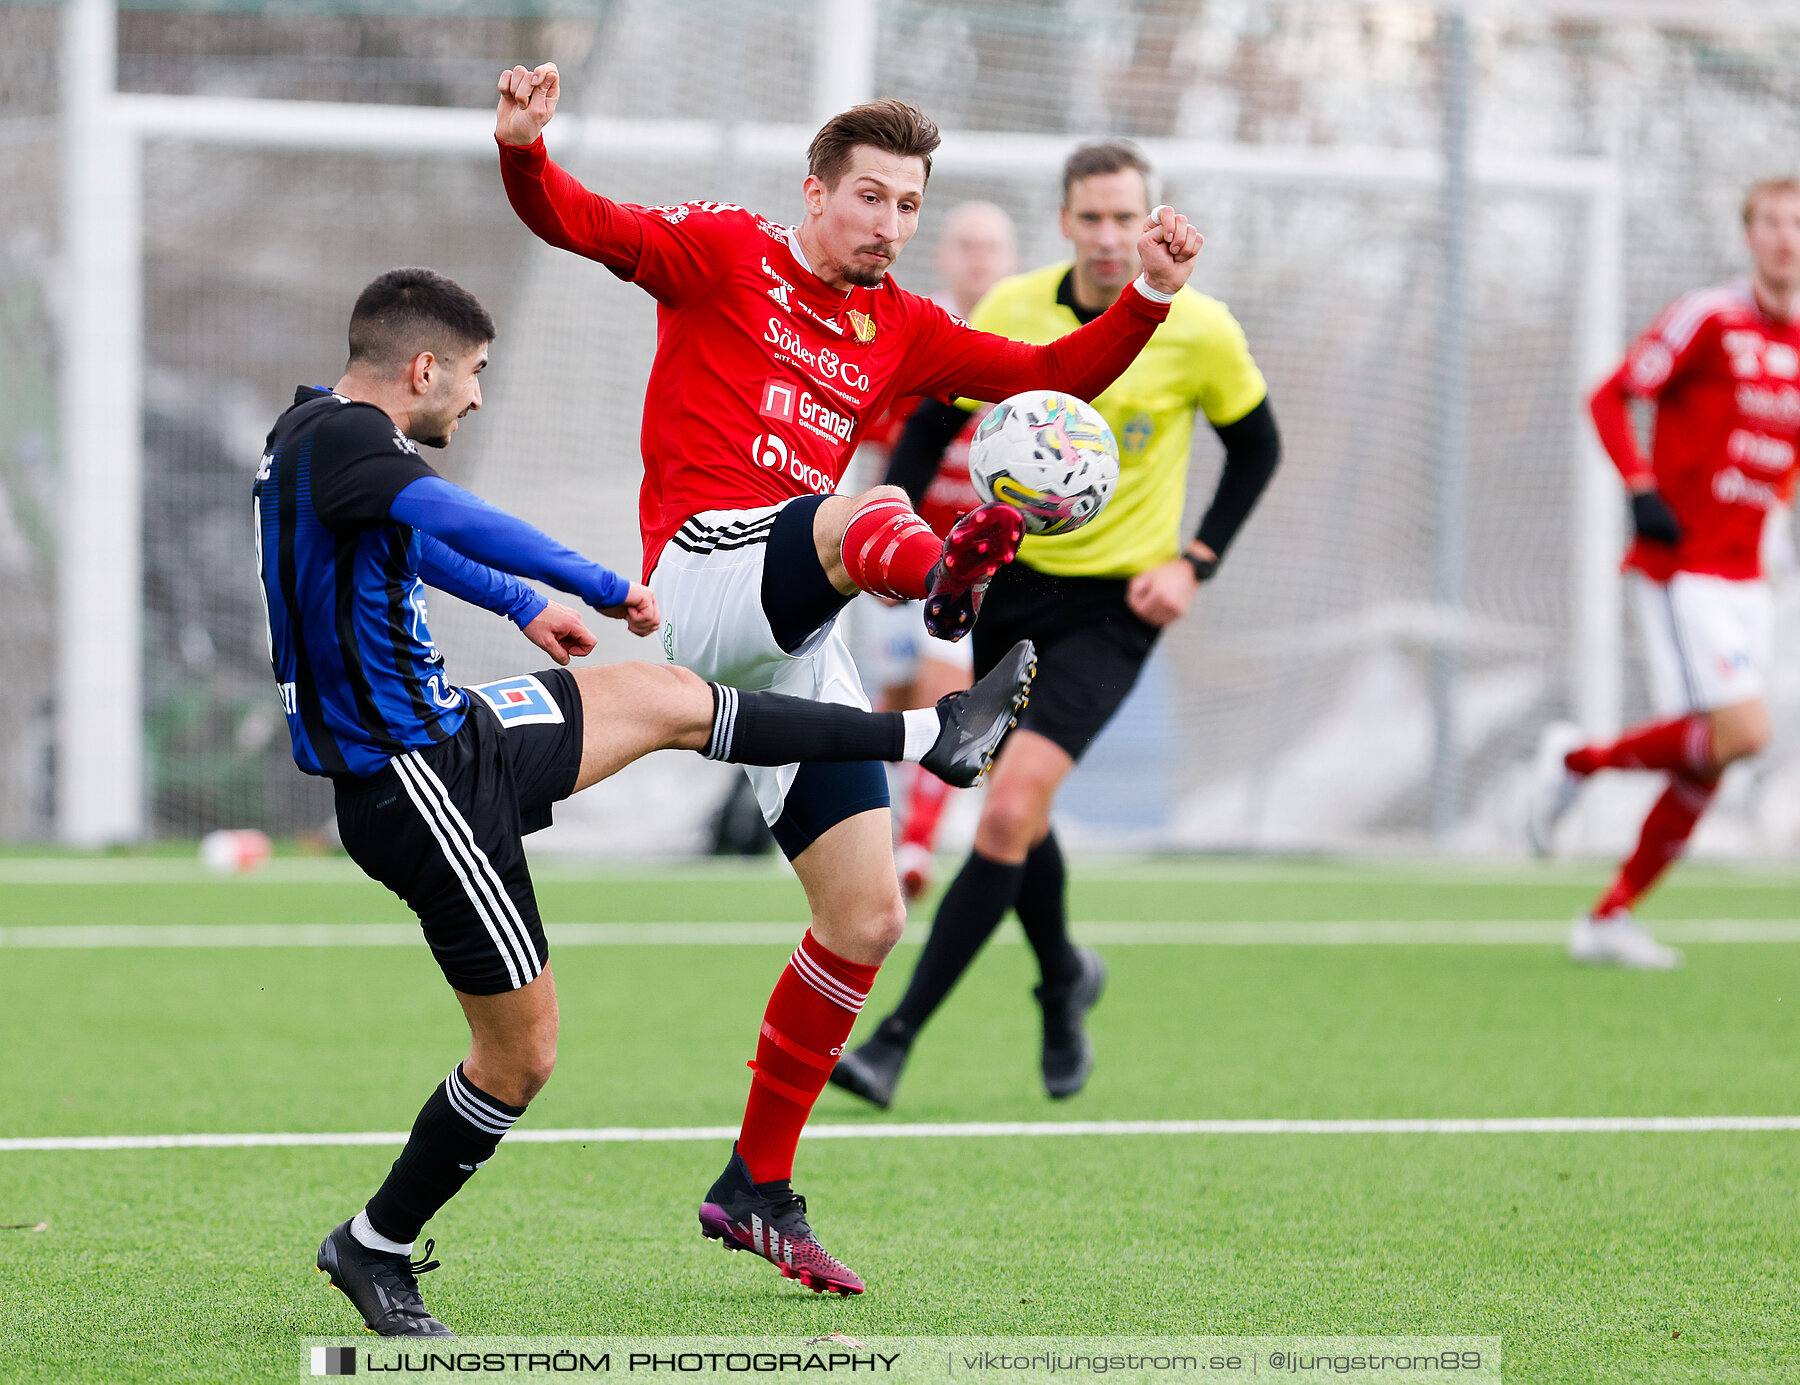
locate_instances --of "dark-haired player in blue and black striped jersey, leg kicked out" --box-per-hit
[282,268,1033,1336]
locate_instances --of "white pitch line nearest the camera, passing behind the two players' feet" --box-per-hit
[0,1115,1800,1153]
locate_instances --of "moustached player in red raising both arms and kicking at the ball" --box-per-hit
[495,63,1201,1293]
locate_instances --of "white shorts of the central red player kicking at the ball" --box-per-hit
[650,504,869,825]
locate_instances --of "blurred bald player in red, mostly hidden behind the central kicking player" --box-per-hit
[859,202,1019,901]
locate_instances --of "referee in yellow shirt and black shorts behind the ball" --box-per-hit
[832,140,1282,1108]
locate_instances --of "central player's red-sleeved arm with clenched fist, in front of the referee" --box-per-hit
[909,207,1202,400]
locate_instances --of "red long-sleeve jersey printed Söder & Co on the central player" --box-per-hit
[500,140,1168,578]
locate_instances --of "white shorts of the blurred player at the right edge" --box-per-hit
[1631,573,1775,717]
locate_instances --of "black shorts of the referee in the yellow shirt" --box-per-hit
[970,562,1161,760]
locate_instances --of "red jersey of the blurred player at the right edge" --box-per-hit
[1589,283,1800,582]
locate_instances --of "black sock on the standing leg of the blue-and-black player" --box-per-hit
[367,1063,526,1243]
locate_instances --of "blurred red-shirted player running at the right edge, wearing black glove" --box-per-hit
[1532,178,1800,969]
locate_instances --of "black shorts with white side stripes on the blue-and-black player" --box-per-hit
[337,668,581,996]
